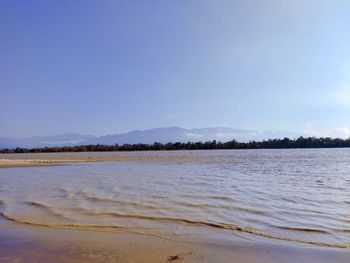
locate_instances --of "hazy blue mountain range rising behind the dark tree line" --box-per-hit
[0,127,299,149]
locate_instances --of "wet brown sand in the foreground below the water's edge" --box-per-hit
[0,220,350,263]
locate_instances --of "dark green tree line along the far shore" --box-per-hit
[0,137,350,153]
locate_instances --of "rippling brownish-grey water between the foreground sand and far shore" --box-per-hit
[0,149,350,247]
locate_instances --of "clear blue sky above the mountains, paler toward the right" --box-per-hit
[0,0,350,137]
